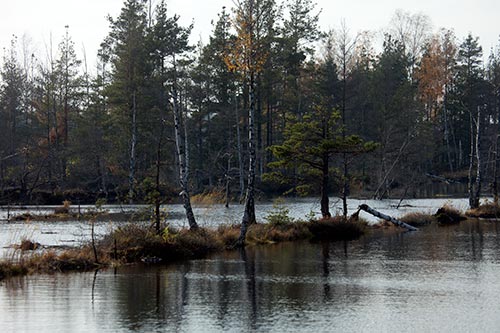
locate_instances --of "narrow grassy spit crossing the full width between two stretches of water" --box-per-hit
[0,200,500,281]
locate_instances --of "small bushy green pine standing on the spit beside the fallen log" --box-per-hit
[268,56,376,218]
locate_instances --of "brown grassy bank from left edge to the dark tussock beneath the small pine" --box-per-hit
[0,215,363,280]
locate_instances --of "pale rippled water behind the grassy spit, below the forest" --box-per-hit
[0,198,468,259]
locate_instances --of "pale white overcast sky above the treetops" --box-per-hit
[0,0,500,66]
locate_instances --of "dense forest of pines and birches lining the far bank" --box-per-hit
[0,0,500,205]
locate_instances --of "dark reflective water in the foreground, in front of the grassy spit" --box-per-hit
[0,221,500,332]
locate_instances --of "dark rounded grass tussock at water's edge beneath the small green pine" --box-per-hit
[307,216,366,241]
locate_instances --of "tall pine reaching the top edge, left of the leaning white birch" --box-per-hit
[102,0,148,202]
